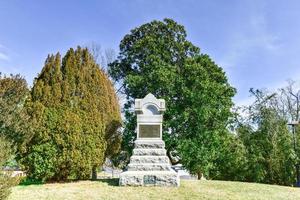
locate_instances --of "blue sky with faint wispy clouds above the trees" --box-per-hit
[0,0,300,104]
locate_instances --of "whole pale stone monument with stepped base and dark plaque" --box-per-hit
[119,93,180,186]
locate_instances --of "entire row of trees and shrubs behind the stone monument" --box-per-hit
[0,19,300,195]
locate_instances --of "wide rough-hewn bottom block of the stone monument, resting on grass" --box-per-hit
[119,171,180,187]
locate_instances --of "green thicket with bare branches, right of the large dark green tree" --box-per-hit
[212,86,300,185]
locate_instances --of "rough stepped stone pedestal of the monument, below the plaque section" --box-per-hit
[119,139,180,186]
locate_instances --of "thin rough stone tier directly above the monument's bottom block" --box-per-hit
[128,163,172,171]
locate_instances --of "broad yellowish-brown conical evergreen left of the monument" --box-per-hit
[20,47,121,181]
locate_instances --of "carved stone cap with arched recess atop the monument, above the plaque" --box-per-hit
[135,93,166,115]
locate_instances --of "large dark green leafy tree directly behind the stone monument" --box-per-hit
[109,19,235,177]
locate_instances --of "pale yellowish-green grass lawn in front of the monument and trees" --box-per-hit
[9,179,300,200]
